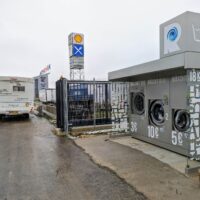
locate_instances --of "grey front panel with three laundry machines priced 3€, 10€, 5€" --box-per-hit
[129,76,191,155]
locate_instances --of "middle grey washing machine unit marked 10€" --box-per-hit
[146,78,172,148]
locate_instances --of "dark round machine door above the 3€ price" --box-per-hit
[132,92,144,115]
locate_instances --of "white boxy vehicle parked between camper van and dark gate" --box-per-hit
[39,88,56,103]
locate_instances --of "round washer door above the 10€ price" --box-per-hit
[150,100,165,126]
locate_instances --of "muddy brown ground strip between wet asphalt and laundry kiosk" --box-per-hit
[75,135,200,200]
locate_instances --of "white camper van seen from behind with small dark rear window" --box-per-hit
[0,76,34,117]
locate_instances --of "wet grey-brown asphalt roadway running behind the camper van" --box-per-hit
[0,116,146,200]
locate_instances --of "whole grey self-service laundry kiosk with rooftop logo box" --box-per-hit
[108,12,200,160]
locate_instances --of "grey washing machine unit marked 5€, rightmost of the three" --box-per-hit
[168,75,191,155]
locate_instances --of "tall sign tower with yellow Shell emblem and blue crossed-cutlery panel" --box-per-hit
[68,33,84,80]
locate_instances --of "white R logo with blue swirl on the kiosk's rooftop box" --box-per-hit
[164,23,181,54]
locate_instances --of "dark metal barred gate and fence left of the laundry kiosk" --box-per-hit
[57,79,111,129]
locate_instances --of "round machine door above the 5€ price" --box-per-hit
[174,110,190,132]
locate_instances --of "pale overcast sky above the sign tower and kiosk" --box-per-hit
[0,0,200,87]
